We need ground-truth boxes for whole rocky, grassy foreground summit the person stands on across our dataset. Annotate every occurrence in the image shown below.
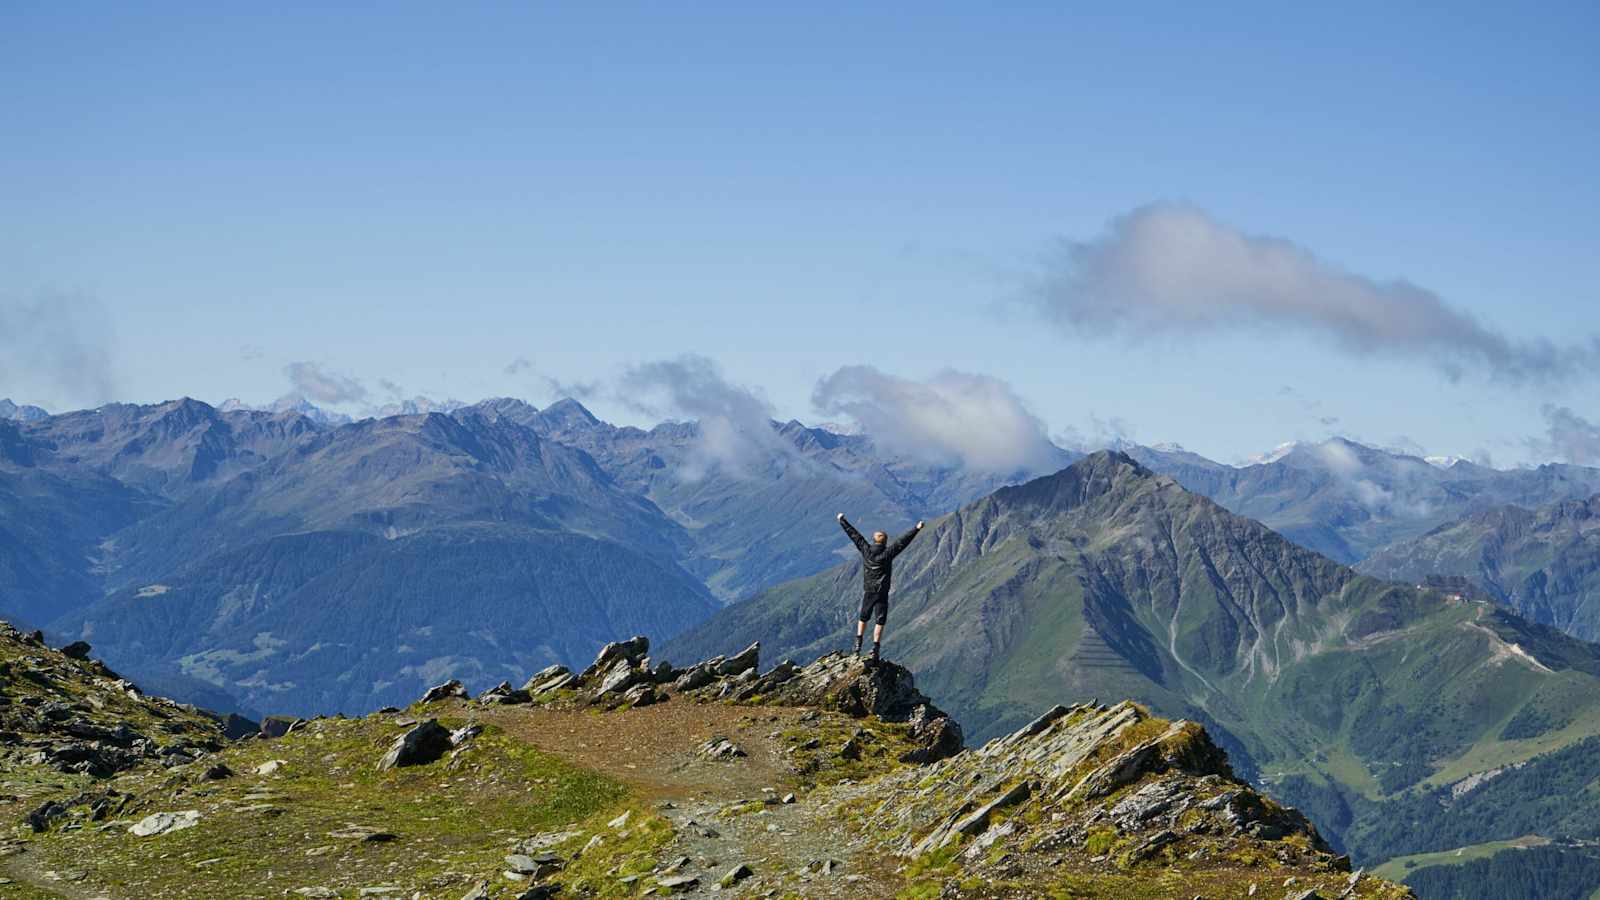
[0,614,1411,900]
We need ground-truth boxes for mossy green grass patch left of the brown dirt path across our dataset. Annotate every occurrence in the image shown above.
[18,716,626,898]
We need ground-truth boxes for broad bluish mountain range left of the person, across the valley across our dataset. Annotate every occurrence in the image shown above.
[9,400,1070,713]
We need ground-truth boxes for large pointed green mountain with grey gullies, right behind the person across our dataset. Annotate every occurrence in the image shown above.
[666,452,1600,883]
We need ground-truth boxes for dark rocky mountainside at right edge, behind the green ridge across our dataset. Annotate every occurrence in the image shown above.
[1358,495,1600,641]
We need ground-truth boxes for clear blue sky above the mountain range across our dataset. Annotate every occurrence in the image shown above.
[0,3,1600,464]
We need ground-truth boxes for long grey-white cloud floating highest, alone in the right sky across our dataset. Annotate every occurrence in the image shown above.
[1030,205,1600,383]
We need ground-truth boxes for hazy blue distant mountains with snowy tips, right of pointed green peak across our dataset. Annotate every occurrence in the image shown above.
[1122,437,1600,564]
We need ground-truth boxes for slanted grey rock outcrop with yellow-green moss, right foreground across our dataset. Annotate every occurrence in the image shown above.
[834,701,1408,898]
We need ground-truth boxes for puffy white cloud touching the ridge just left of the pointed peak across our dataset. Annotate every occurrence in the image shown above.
[811,365,1059,472]
